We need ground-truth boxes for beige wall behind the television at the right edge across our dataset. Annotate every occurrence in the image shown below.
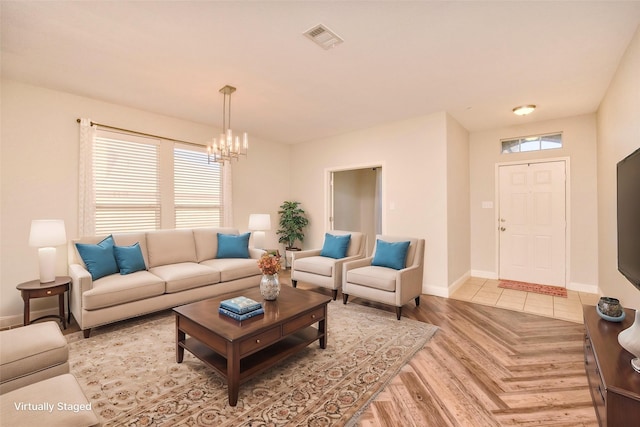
[598,28,640,309]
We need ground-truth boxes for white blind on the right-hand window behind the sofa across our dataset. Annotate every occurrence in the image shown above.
[173,146,224,228]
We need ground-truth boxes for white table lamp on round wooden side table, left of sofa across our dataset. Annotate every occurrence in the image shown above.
[29,219,67,283]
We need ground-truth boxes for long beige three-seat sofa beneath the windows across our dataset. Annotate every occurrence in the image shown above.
[69,227,263,337]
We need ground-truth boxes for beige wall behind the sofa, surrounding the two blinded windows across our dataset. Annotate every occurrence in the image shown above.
[0,80,289,325]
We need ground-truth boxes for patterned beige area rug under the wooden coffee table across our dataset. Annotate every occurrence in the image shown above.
[67,302,437,427]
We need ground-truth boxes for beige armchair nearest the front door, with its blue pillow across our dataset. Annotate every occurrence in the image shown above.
[342,235,424,320]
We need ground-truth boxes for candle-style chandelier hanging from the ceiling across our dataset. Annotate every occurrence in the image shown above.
[207,85,249,163]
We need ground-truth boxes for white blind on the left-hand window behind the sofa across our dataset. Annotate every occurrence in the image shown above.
[93,131,160,234]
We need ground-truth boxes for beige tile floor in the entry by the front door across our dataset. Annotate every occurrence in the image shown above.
[451,277,600,323]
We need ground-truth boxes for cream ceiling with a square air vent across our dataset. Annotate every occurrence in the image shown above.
[0,0,640,143]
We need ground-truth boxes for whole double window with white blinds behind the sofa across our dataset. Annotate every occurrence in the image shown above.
[93,129,223,234]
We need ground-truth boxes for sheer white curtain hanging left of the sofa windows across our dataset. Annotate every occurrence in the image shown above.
[78,119,97,236]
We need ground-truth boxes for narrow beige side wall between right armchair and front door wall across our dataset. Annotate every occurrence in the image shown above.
[447,116,471,285]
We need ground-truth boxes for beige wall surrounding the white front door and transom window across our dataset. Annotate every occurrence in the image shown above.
[470,113,598,292]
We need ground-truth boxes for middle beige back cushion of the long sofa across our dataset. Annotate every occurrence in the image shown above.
[147,229,196,268]
